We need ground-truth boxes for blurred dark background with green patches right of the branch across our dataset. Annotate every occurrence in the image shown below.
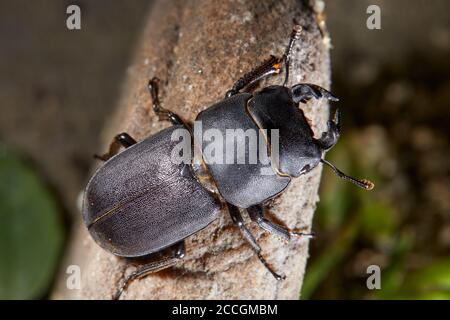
[302,1,450,299]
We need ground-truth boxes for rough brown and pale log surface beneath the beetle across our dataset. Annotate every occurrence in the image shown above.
[53,0,330,299]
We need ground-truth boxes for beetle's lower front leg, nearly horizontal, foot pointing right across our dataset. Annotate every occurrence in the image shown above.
[247,204,315,241]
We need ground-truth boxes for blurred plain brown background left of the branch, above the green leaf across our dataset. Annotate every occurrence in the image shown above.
[0,0,150,298]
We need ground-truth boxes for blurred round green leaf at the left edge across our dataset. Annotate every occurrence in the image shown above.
[0,144,63,299]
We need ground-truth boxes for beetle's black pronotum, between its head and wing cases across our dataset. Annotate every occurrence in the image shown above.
[196,93,290,208]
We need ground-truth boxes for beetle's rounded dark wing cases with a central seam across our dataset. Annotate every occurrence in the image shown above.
[83,125,221,257]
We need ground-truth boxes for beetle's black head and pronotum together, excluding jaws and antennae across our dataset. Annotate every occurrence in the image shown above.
[196,86,322,208]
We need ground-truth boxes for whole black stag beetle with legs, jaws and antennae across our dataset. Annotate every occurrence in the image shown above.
[82,26,373,298]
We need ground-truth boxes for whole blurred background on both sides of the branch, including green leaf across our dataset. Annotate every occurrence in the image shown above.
[0,0,450,299]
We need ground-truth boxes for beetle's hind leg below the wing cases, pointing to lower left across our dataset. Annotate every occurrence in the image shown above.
[114,241,186,300]
